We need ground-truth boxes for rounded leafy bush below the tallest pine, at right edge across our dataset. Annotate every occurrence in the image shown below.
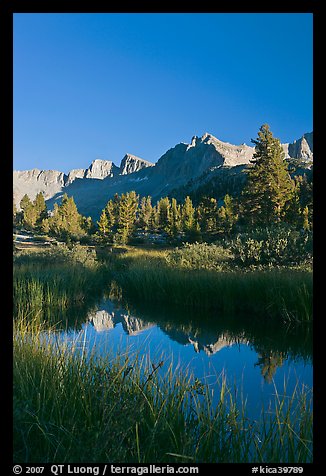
[230,226,312,266]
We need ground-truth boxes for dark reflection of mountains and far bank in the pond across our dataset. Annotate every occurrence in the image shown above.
[86,300,312,365]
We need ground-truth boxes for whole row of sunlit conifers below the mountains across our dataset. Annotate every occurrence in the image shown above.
[14,124,313,244]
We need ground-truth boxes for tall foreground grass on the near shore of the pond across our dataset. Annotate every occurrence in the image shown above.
[13,319,312,463]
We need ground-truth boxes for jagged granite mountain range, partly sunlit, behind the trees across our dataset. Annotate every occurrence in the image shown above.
[13,132,313,219]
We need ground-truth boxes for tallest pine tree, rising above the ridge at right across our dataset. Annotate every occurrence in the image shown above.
[242,124,293,225]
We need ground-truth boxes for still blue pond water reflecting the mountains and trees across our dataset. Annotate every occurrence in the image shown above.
[51,299,313,418]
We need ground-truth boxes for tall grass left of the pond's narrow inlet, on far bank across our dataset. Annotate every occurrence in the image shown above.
[13,247,111,324]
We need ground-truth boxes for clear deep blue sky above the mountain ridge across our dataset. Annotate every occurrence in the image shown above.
[13,13,313,172]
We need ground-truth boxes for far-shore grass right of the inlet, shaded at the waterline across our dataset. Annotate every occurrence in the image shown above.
[109,250,312,322]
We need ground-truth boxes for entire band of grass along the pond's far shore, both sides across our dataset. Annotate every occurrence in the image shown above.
[14,247,312,323]
